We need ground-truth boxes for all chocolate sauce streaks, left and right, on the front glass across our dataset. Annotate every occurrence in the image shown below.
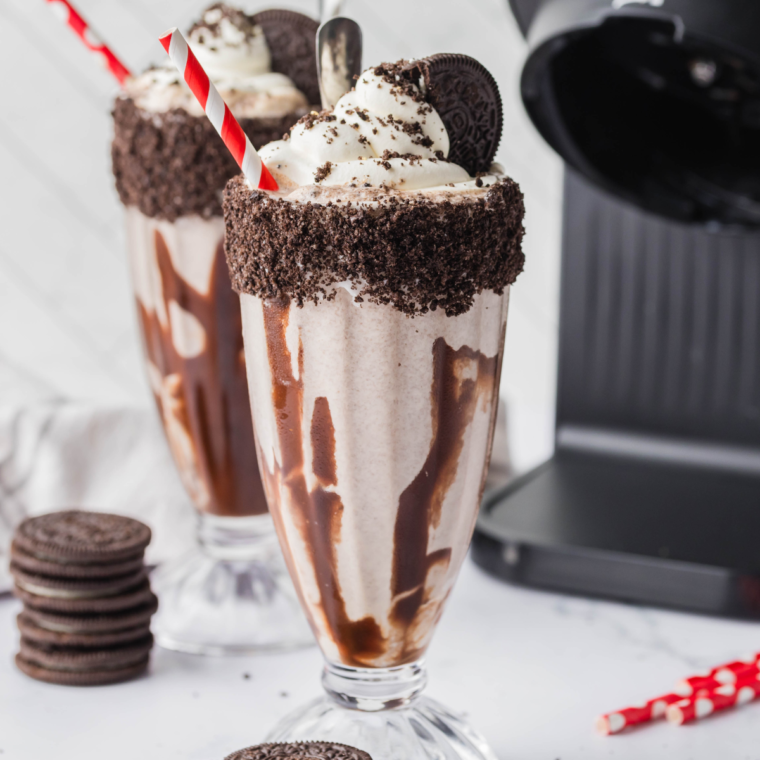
[262,300,500,667]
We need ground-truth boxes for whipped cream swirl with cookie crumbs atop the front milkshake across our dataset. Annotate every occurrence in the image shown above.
[260,69,500,194]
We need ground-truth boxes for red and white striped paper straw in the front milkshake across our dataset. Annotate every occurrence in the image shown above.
[159,28,279,190]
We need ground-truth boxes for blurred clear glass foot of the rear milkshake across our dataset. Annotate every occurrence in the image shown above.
[151,515,314,655]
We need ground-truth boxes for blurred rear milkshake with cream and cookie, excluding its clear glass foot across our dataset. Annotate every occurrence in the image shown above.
[113,4,317,516]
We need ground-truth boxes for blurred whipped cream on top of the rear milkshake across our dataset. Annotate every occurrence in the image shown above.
[127,4,308,118]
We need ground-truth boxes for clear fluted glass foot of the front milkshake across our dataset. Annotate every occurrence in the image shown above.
[266,663,496,760]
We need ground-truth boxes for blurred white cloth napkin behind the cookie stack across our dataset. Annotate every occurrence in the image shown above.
[0,402,195,591]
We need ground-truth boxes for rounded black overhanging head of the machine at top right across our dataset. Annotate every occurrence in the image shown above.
[513,0,760,228]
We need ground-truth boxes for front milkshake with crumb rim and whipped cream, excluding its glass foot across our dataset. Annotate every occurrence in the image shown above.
[225,56,523,667]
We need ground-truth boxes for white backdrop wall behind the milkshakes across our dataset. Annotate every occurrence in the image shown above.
[0,0,561,504]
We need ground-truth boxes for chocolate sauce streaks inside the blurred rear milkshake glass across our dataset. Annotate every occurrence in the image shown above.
[137,230,267,517]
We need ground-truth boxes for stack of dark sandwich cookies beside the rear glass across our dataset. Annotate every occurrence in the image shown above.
[11,510,158,686]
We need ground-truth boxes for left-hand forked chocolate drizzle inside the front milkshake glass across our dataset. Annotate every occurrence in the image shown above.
[263,301,385,667]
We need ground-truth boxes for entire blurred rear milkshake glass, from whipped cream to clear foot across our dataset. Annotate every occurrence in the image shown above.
[113,4,318,654]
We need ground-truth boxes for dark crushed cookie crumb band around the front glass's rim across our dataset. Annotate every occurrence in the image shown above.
[224,177,524,316]
